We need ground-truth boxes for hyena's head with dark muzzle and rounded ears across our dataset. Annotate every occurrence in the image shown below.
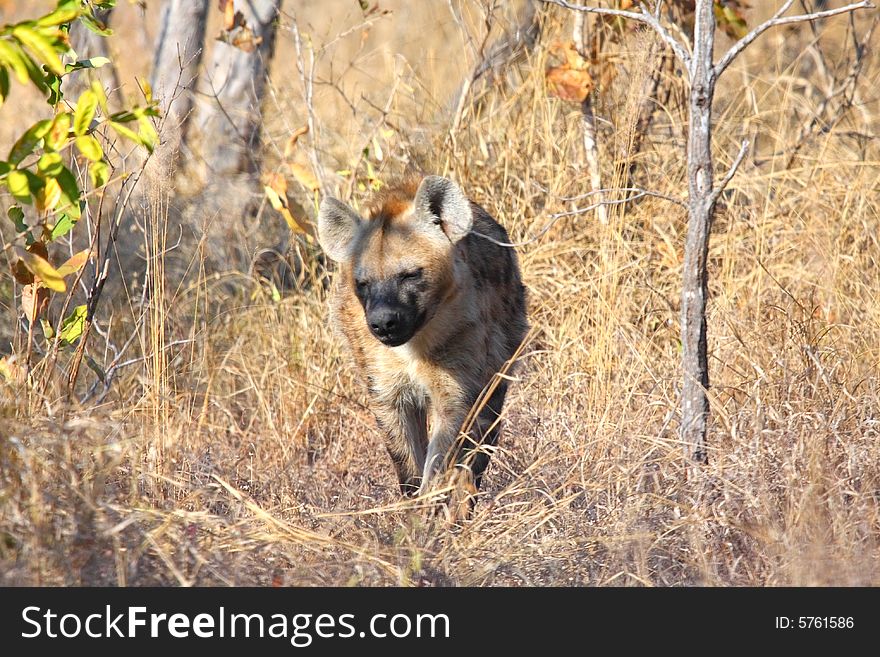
[318,176,473,347]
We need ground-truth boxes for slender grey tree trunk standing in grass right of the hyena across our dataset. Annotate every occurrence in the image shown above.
[681,0,715,463]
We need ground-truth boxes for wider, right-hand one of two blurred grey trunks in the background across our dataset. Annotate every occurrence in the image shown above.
[197,0,281,178]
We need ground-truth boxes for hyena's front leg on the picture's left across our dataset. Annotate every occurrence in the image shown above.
[374,394,428,495]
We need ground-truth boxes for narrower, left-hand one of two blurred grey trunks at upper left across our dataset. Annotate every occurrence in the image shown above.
[150,0,210,160]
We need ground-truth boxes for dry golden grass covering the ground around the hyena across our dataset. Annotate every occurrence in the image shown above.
[0,3,880,586]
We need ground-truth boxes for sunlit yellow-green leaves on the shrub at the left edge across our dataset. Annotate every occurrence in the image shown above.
[0,0,159,358]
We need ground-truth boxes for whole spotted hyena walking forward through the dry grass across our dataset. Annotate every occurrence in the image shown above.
[318,176,528,495]
